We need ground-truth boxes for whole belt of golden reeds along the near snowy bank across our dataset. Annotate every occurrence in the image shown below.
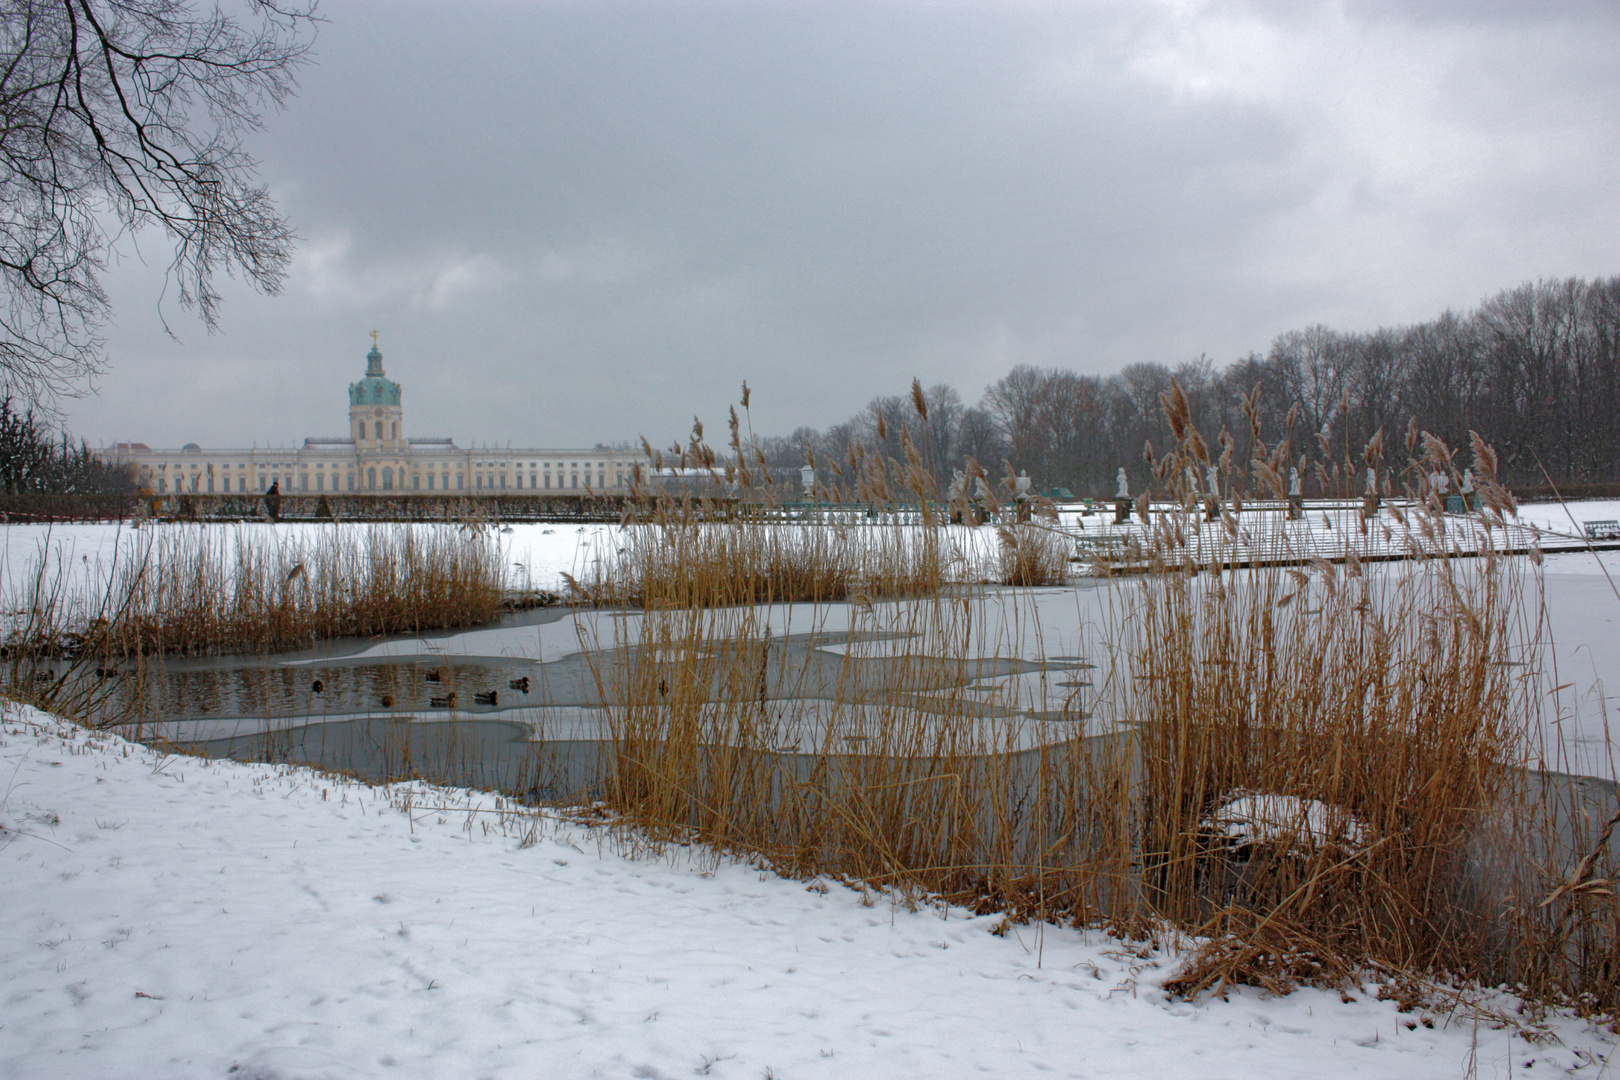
[573,386,1620,1015]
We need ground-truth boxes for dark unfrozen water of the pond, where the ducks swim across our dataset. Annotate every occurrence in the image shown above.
[85,610,1090,798]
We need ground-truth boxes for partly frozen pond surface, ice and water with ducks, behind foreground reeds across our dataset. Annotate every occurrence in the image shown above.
[91,583,1103,790]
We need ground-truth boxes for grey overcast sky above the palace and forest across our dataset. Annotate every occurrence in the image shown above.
[66,0,1620,447]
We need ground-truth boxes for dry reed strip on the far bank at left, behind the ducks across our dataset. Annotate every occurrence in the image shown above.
[0,526,504,664]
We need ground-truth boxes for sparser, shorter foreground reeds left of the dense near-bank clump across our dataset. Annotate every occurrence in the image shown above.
[583,597,1088,894]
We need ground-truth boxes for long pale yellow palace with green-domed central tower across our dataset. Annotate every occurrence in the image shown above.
[102,332,642,499]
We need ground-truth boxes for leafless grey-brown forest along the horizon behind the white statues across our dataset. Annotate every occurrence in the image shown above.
[757,277,1620,495]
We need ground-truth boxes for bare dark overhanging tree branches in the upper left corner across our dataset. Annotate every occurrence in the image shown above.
[0,0,314,403]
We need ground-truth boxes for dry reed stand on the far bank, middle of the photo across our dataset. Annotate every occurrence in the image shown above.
[596,385,1072,609]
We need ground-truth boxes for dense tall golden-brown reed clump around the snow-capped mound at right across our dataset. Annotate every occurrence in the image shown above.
[1128,527,1534,991]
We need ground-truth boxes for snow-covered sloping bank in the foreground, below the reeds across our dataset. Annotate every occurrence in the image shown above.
[0,706,1615,1080]
